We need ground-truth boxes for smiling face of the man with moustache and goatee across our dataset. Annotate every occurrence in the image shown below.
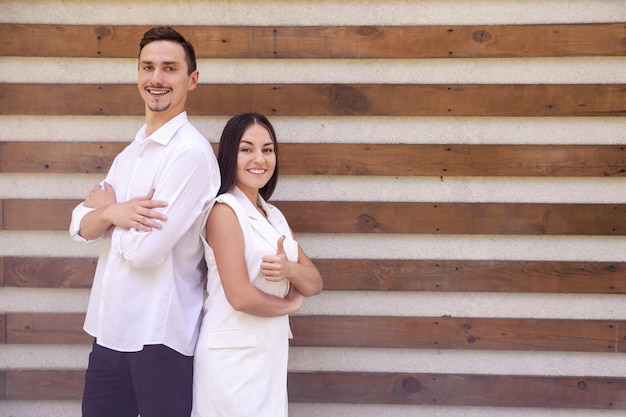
[137,41,198,118]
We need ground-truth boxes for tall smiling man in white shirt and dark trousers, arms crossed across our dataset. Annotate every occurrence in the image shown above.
[70,27,220,417]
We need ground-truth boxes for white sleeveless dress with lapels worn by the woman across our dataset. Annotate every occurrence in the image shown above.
[192,187,298,417]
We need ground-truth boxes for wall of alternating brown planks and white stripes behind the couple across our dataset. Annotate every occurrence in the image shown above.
[0,0,626,417]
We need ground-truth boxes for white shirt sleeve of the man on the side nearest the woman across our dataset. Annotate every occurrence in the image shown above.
[111,142,220,268]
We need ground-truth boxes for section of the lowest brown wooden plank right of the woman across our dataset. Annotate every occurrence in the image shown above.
[288,372,626,410]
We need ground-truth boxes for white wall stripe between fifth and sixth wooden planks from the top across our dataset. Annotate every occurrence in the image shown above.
[0,287,626,320]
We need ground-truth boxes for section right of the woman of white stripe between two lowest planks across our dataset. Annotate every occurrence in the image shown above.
[289,347,626,378]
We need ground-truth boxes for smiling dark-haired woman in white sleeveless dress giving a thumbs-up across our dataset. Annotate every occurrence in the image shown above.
[192,113,322,417]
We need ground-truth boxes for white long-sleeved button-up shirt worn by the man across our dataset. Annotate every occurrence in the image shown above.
[70,112,220,356]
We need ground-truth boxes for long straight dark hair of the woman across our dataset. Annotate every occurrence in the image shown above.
[217,113,278,201]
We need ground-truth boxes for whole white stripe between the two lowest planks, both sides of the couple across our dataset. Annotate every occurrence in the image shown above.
[0,344,624,378]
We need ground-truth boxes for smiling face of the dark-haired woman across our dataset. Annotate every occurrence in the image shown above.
[235,124,276,194]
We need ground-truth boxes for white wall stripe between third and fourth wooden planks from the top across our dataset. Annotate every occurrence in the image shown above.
[0,174,626,204]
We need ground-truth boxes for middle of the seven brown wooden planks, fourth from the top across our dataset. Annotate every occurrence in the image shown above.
[3,199,626,236]
